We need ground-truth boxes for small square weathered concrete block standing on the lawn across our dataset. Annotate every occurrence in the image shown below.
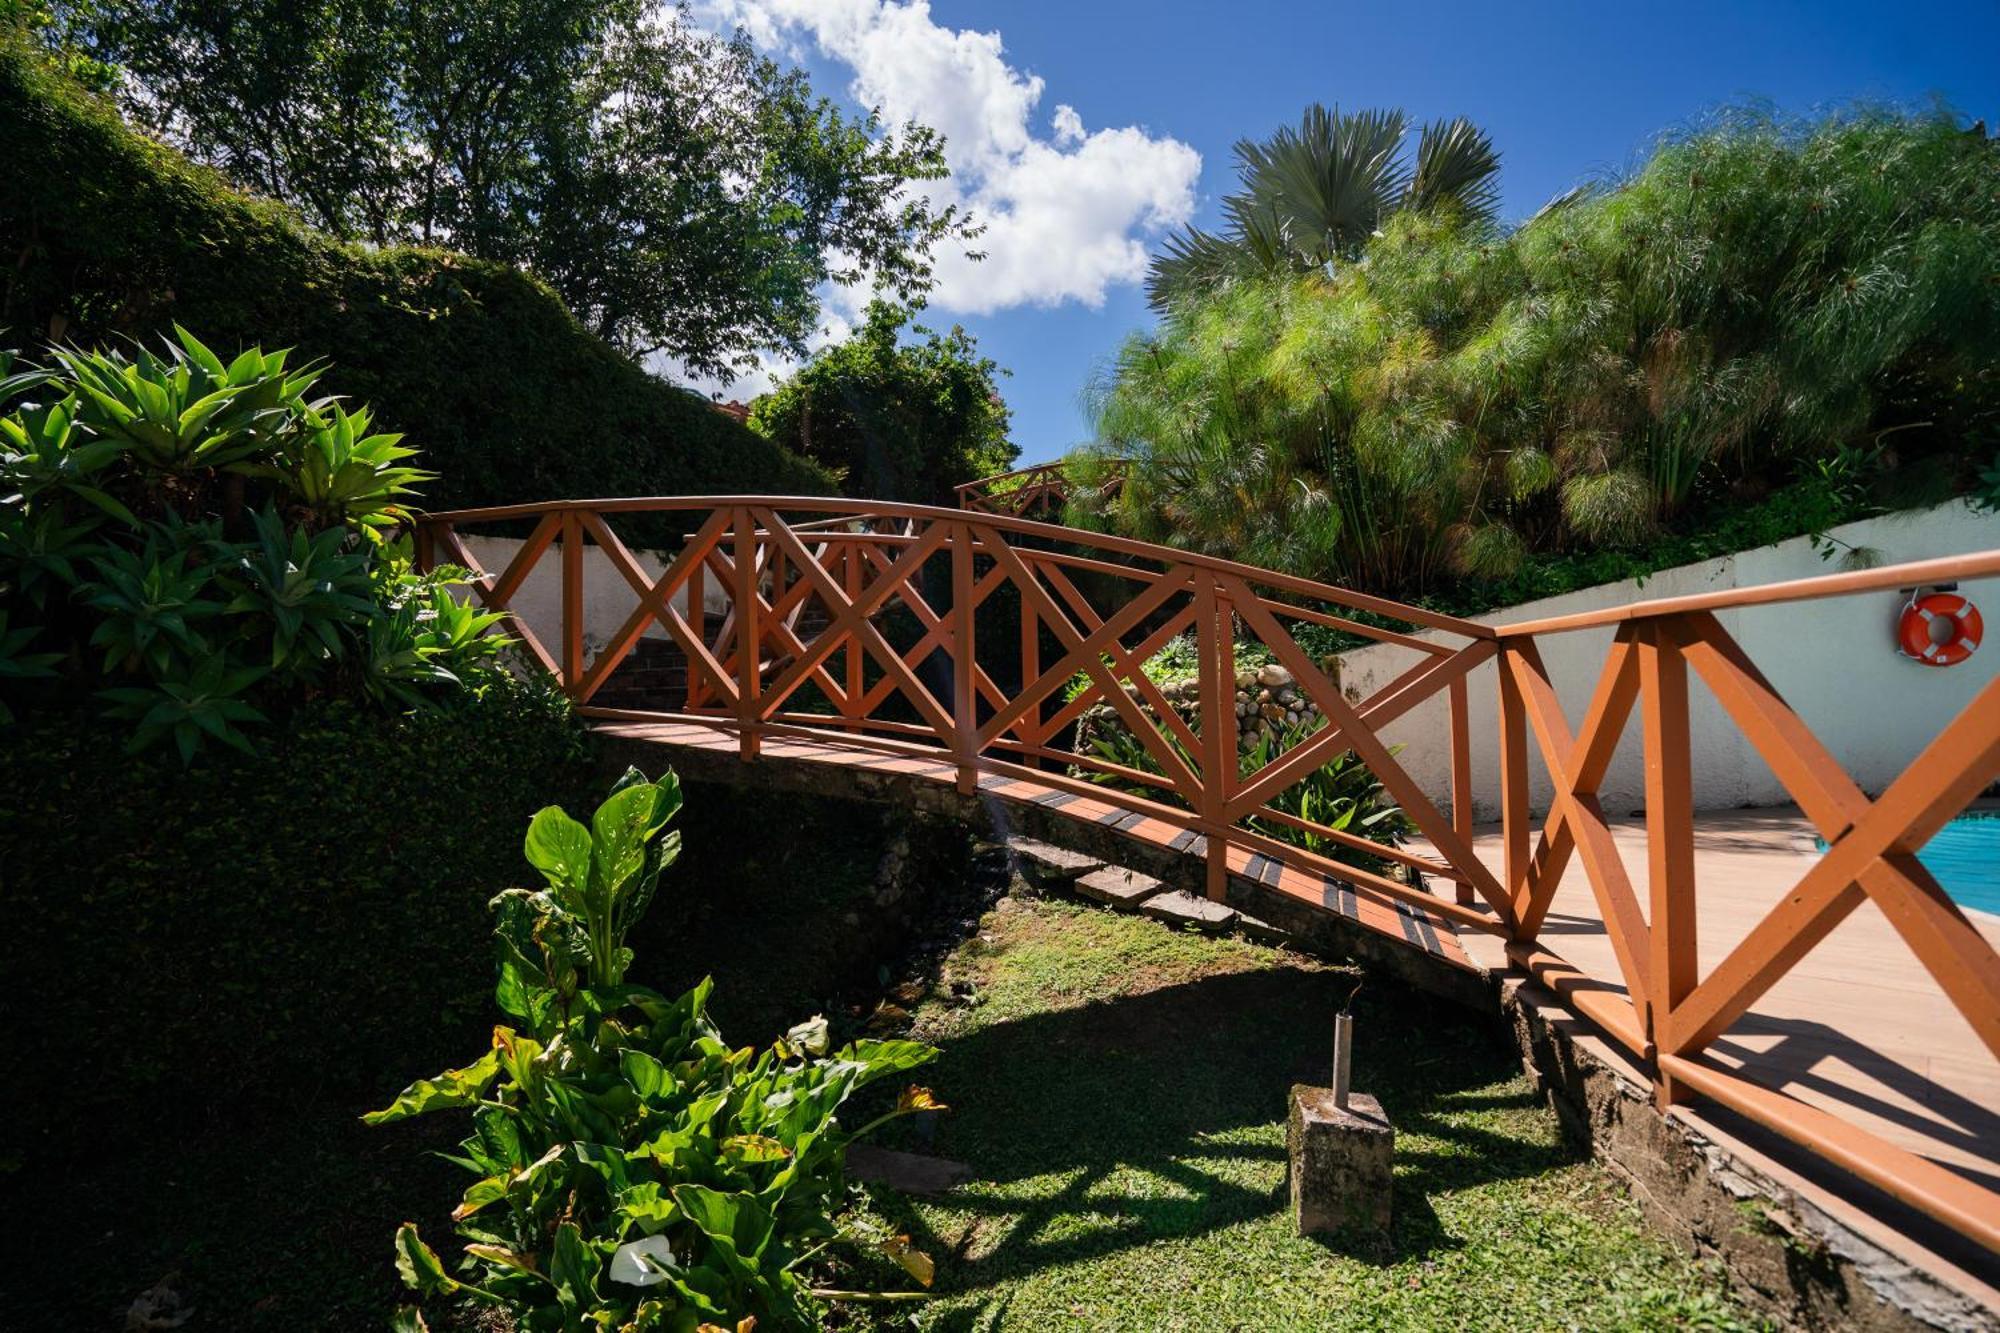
[1286,1083,1396,1237]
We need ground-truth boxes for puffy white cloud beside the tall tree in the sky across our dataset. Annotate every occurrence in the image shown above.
[696,0,1202,314]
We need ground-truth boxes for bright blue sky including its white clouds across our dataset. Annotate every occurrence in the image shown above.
[702,0,2000,462]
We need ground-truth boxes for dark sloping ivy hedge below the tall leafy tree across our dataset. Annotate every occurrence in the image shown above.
[0,38,832,508]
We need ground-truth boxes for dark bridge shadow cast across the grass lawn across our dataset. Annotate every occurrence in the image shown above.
[882,967,1576,1288]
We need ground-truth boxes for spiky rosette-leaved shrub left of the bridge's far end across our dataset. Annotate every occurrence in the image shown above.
[0,330,532,761]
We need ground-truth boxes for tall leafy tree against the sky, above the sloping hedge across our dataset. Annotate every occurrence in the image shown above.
[54,0,970,372]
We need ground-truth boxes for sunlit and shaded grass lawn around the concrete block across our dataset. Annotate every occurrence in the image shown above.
[852,899,1754,1329]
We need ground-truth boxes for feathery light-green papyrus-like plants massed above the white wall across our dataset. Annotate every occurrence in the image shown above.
[1082,112,2000,594]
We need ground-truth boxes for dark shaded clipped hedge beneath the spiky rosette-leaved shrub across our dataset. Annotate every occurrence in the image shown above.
[0,685,600,1153]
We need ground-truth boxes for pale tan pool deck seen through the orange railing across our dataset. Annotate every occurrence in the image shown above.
[1460,807,2000,1189]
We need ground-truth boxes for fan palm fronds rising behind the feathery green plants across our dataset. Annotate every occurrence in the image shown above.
[1146,102,1500,310]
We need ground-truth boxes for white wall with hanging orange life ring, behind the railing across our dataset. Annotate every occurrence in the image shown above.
[1342,500,2000,819]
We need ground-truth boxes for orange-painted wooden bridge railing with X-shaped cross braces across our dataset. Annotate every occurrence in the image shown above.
[418,496,2000,1253]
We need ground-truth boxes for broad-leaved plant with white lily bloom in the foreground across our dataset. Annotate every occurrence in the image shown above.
[382,769,936,1333]
